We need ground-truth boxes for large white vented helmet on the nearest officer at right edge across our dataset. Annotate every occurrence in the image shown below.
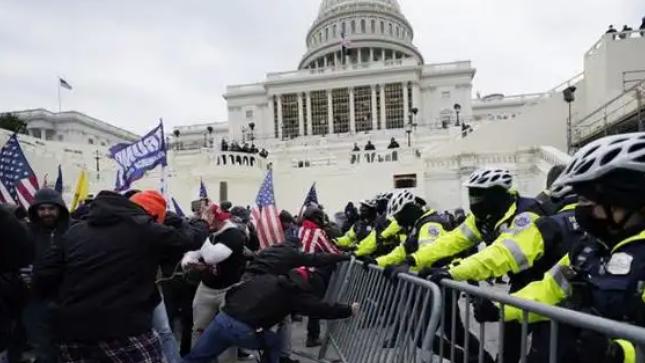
[553,132,645,185]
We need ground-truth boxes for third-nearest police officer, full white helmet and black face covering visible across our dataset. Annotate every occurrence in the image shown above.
[399,168,542,362]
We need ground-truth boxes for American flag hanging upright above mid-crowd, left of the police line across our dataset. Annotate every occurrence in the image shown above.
[251,170,284,248]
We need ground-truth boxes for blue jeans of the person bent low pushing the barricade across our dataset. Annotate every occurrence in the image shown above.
[184,312,281,363]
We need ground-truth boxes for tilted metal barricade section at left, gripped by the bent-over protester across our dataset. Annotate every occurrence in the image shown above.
[318,260,441,363]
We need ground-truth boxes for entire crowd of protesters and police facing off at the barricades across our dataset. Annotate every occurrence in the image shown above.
[0,133,645,363]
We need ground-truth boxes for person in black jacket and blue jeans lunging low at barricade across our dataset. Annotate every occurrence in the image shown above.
[184,268,359,363]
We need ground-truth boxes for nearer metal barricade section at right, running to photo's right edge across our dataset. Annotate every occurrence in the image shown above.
[432,280,645,363]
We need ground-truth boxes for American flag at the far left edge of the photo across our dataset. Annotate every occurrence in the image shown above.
[0,134,39,208]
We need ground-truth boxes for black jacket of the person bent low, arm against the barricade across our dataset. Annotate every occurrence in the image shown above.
[222,275,352,329]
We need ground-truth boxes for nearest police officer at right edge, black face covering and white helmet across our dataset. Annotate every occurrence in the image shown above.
[505,133,645,363]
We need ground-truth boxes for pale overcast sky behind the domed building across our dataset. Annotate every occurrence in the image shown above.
[0,0,645,133]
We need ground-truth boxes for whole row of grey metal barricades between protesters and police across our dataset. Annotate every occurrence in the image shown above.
[318,261,645,363]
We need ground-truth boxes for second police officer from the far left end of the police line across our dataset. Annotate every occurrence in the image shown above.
[354,192,405,259]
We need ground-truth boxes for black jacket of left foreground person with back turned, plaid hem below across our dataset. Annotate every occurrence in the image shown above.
[34,192,204,342]
